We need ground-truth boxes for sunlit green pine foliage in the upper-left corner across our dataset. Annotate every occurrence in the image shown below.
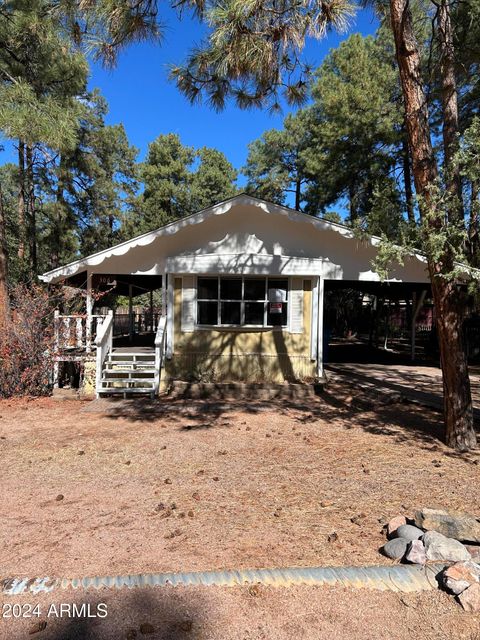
[0,0,88,148]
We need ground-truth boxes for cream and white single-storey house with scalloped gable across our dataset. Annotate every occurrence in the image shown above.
[41,194,429,395]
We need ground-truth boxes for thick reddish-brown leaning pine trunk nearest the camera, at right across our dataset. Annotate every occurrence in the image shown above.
[390,0,476,450]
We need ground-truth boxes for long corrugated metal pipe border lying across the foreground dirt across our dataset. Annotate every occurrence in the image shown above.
[0,563,448,596]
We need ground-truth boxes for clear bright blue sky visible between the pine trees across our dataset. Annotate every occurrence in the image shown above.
[0,10,377,180]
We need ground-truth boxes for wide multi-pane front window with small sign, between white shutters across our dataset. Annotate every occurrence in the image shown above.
[197,277,288,327]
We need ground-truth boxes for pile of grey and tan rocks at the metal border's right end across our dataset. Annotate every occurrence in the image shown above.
[381,509,480,611]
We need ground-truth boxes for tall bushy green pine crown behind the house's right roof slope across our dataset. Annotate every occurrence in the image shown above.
[303,32,404,229]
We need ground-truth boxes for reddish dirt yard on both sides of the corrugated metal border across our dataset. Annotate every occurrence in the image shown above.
[0,381,480,640]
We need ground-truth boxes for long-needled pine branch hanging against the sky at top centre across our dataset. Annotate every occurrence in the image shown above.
[171,0,354,110]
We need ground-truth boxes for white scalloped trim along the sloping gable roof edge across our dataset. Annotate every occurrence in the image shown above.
[39,193,424,283]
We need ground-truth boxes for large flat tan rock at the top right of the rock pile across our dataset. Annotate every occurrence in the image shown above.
[415,509,480,542]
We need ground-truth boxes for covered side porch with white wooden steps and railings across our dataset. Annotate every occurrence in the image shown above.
[54,274,166,398]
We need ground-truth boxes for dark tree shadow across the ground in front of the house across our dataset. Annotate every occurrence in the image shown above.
[81,380,478,461]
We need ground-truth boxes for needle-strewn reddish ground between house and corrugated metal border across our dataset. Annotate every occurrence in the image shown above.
[0,383,480,577]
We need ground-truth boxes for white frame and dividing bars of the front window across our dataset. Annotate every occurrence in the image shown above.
[195,274,291,331]
